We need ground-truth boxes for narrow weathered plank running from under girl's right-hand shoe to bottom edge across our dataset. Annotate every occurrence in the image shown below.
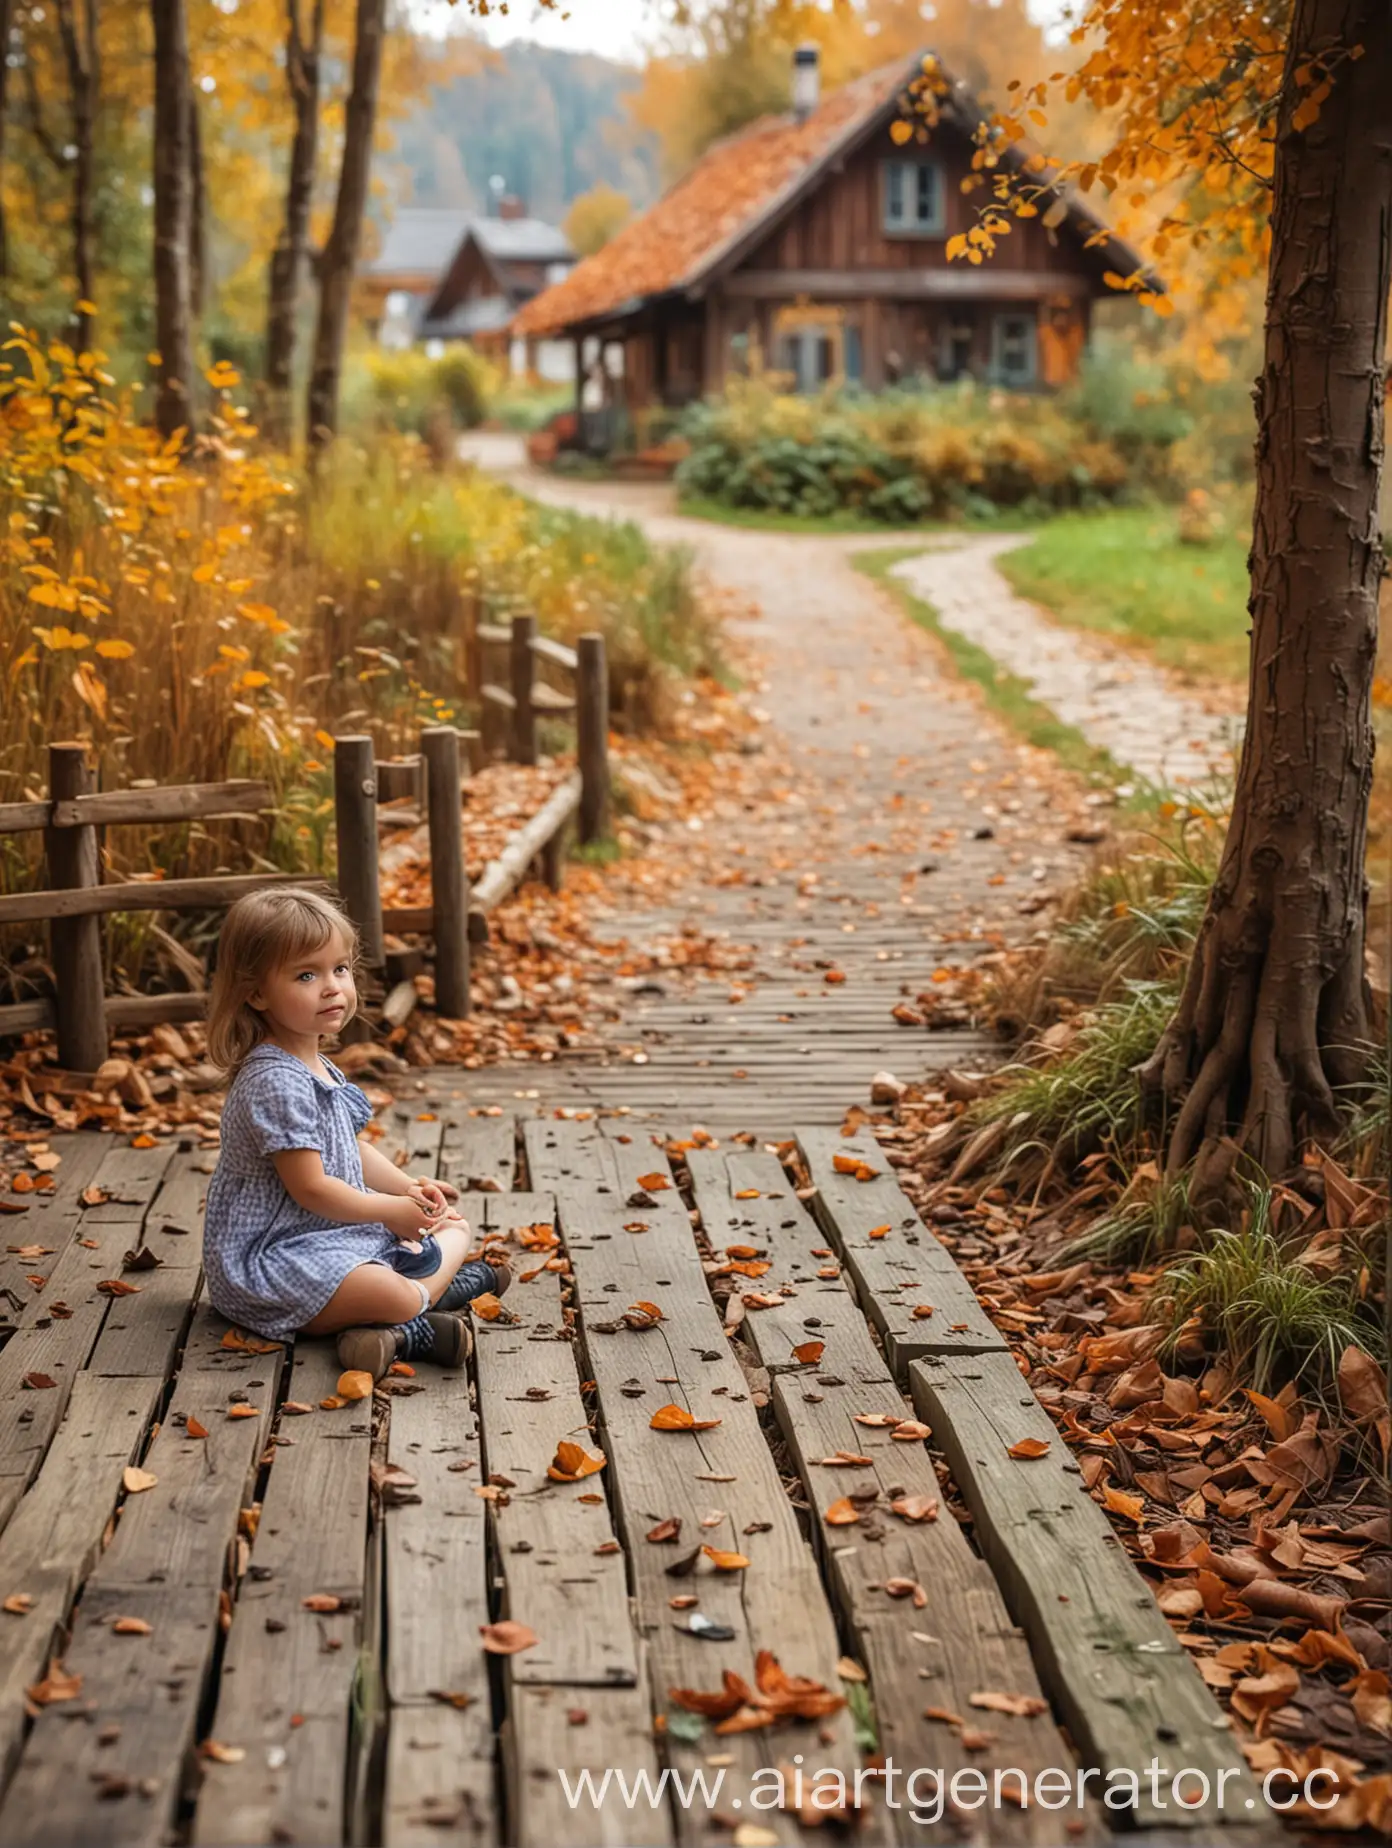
[383,1368,503,1848]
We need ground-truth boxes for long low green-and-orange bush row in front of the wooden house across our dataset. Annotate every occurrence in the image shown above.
[677,377,1153,525]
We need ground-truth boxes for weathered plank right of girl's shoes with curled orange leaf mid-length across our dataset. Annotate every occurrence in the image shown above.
[464,1194,638,1687]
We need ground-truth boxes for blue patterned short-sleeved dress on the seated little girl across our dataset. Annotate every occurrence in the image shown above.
[203,1040,440,1342]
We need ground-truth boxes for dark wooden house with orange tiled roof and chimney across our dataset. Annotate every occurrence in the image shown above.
[514,46,1159,432]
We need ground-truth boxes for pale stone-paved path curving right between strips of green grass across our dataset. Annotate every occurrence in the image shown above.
[895,534,1237,789]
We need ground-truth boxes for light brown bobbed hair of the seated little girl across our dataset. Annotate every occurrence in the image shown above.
[207,885,359,1077]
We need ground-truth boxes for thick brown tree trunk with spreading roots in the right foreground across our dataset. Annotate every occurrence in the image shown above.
[1141,0,1392,1188]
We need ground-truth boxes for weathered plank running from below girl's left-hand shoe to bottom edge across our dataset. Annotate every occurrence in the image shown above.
[192,1342,375,1842]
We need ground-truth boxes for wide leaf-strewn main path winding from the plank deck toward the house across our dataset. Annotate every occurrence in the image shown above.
[428,438,1098,1129]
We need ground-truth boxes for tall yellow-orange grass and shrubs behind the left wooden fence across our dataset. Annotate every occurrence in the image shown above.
[0,340,715,889]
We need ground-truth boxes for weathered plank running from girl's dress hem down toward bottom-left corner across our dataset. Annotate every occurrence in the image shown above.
[0,1310,283,1848]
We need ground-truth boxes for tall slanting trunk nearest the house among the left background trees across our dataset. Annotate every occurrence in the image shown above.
[307,0,386,449]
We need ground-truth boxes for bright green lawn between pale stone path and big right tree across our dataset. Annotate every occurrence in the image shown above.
[996,506,1248,680]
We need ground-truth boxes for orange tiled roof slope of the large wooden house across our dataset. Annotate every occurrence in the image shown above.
[514,59,917,334]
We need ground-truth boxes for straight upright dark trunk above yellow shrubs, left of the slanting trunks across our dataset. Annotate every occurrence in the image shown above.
[150,0,194,438]
